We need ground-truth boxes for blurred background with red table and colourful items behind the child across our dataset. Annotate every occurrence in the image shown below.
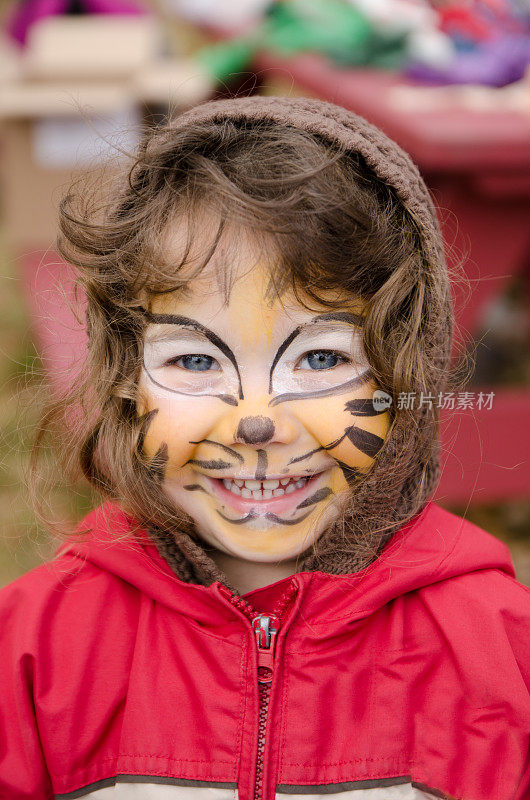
[0,0,530,586]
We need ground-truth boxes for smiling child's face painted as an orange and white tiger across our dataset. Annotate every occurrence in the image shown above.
[138,225,390,563]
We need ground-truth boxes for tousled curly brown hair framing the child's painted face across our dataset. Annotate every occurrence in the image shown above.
[29,108,453,580]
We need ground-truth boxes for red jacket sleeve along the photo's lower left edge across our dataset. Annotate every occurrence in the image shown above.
[0,576,54,800]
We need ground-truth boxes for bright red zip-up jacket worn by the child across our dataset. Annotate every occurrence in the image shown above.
[0,503,530,800]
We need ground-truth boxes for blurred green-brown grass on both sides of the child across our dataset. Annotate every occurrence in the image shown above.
[0,234,530,586]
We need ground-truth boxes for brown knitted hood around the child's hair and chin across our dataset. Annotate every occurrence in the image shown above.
[139,97,452,585]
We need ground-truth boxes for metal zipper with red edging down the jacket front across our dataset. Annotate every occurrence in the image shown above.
[220,585,298,800]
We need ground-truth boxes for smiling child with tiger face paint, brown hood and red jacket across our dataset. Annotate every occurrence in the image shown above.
[0,97,530,800]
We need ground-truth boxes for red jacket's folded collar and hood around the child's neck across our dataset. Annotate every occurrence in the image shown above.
[58,502,514,625]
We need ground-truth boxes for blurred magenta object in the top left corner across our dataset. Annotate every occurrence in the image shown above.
[7,0,147,45]
